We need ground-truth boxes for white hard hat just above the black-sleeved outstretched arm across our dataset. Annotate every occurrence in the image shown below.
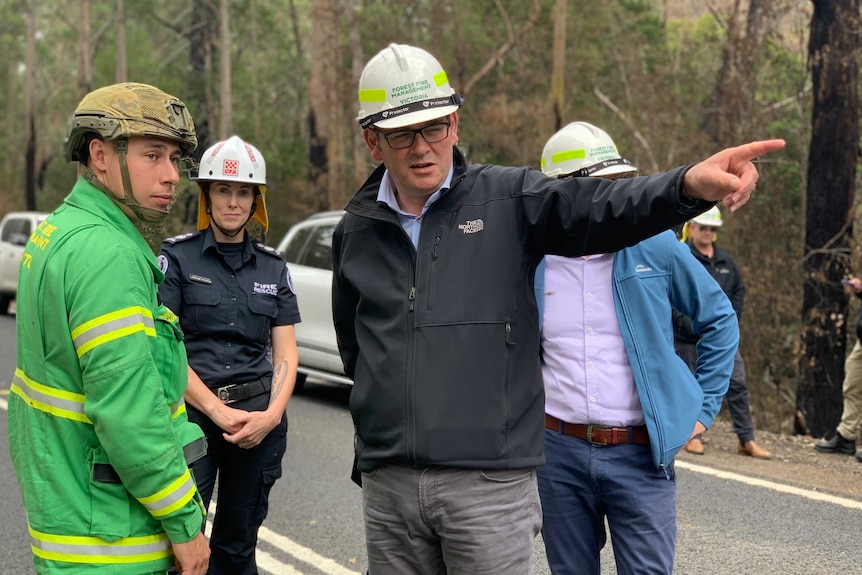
[542,122,638,178]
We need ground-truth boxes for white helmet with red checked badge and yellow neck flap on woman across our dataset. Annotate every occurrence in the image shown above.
[196,136,269,232]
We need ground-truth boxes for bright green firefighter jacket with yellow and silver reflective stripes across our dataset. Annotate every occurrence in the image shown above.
[8,179,205,574]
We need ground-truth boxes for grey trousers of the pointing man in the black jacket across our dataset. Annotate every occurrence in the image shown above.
[362,465,542,575]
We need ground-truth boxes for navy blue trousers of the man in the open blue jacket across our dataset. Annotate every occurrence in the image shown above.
[536,429,676,575]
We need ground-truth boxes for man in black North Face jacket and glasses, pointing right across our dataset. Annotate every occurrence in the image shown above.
[332,44,783,575]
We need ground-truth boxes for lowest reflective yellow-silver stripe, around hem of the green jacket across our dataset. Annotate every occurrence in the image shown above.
[28,525,173,564]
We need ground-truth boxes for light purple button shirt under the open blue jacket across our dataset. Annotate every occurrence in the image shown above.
[542,254,644,426]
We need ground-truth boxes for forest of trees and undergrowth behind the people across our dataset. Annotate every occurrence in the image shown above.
[0,0,862,436]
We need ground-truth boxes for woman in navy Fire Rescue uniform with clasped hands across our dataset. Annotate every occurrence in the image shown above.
[159,136,300,575]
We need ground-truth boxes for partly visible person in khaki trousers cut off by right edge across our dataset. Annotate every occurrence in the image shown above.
[814,277,862,462]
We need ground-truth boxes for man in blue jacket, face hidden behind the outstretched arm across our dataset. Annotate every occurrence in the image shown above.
[535,122,739,575]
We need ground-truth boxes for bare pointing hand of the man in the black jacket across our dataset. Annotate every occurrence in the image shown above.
[683,140,784,212]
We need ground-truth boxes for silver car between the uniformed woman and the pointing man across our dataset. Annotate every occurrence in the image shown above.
[278,210,353,391]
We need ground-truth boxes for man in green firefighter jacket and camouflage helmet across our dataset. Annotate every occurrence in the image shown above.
[8,82,210,575]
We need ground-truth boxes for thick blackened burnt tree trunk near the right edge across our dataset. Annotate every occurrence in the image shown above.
[795,0,860,437]
